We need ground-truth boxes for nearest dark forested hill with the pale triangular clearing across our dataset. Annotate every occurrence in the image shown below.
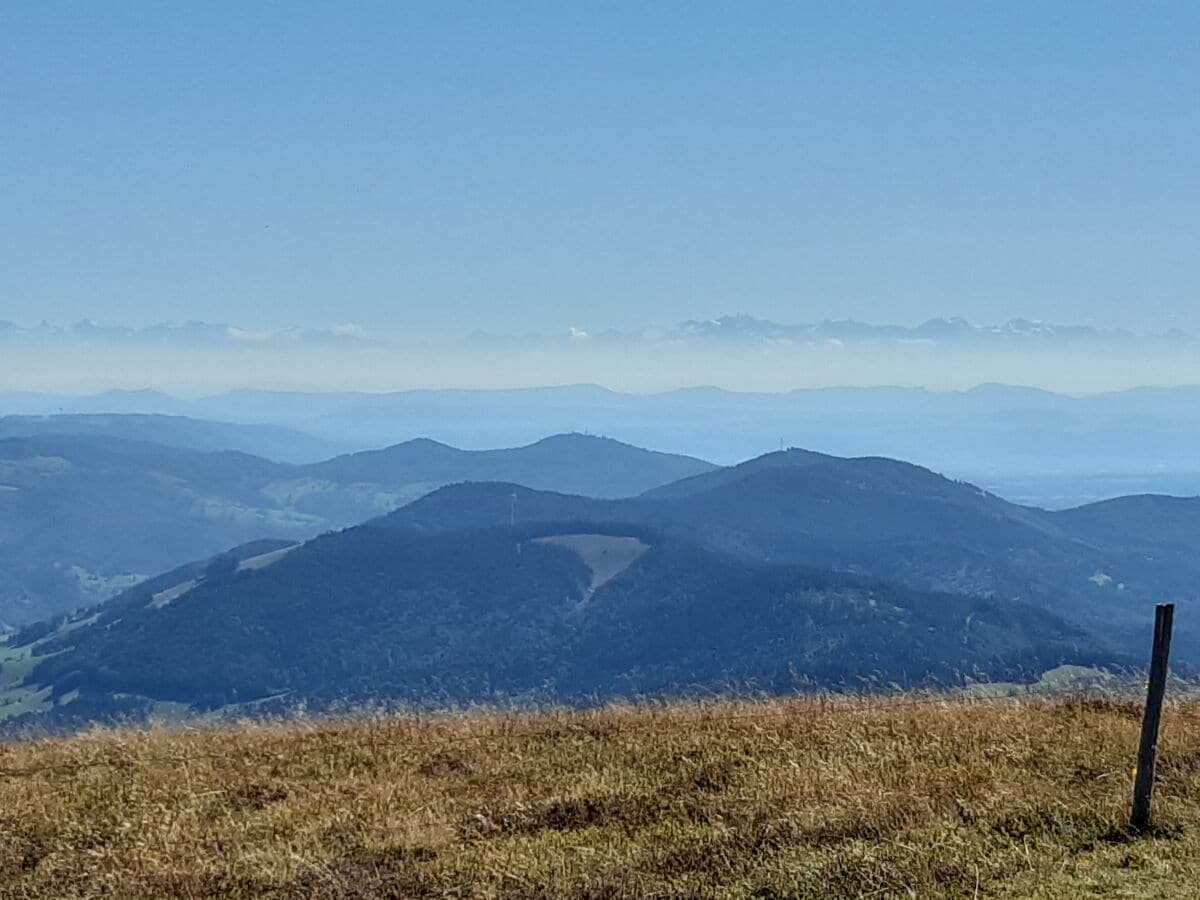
[0,523,1114,734]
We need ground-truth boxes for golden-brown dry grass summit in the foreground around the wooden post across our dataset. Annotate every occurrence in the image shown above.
[0,700,1200,898]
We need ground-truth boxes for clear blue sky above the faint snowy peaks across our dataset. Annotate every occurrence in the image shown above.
[0,0,1200,335]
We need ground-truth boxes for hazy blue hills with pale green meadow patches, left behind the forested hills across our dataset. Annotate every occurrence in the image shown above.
[0,432,713,625]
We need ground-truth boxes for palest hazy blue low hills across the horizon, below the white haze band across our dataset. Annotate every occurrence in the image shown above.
[7,385,1200,508]
